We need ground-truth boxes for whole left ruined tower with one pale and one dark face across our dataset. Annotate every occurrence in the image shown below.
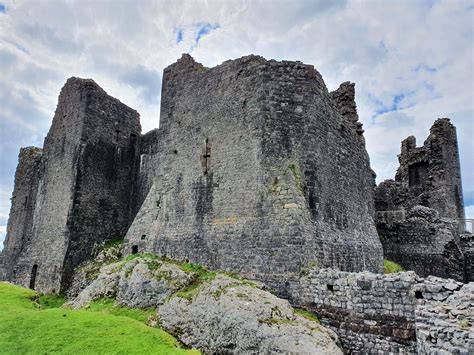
[3,78,141,292]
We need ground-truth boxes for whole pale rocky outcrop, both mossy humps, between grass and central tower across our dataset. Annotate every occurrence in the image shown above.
[66,255,342,354]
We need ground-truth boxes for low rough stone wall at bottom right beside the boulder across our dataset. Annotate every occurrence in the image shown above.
[290,269,474,354]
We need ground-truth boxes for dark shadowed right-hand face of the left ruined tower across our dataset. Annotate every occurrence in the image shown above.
[62,80,141,288]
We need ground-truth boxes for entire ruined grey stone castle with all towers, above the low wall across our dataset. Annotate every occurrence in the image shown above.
[0,55,472,299]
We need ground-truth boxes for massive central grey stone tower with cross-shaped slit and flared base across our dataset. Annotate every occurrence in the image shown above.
[126,55,382,294]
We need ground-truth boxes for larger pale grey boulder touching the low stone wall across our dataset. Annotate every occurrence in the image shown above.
[158,275,341,354]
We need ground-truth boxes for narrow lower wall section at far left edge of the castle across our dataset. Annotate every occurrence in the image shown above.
[1,147,42,280]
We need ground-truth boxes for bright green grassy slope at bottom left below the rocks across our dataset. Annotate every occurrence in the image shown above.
[0,282,198,354]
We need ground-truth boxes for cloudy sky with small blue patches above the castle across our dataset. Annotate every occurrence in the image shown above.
[0,0,474,249]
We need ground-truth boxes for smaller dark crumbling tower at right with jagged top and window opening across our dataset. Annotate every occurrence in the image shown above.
[375,118,473,281]
